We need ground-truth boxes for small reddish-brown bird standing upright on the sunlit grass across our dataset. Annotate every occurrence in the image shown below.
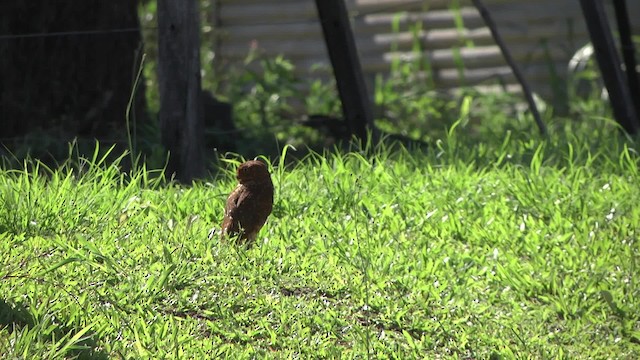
[221,160,273,244]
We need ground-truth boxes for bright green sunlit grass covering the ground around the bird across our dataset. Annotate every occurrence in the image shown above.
[0,119,640,359]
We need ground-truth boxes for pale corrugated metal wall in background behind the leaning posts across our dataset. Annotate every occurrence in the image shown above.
[216,0,640,96]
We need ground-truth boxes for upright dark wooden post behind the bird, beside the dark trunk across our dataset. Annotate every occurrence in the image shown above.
[157,0,205,183]
